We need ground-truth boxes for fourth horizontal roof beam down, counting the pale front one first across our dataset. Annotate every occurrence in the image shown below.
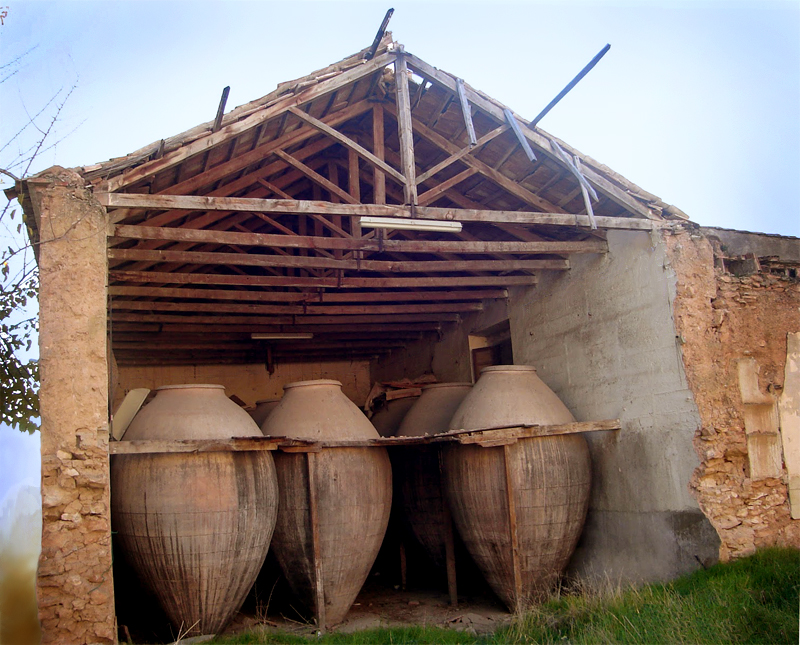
[109,269,538,290]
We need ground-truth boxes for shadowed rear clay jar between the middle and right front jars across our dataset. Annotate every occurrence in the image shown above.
[392,383,472,568]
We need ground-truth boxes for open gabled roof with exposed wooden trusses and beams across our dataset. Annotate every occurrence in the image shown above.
[43,34,685,365]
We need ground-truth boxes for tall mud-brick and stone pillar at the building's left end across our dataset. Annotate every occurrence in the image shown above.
[28,168,116,644]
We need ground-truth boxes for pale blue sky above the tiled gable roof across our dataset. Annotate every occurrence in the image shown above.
[0,0,800,498]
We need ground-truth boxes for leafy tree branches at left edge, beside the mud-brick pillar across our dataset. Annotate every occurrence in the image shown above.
[0,48,75,433]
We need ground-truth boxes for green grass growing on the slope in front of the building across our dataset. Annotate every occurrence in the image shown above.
[214,548,800,645]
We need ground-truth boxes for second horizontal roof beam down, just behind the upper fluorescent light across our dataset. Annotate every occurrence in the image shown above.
[110,224,608,254]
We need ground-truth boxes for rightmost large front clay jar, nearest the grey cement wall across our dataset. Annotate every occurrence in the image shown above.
[443,365,591,611]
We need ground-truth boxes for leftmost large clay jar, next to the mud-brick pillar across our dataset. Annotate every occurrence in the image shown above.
[111,385,278,634]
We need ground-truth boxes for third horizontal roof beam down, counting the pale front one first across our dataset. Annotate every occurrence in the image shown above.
[108,248,569,273]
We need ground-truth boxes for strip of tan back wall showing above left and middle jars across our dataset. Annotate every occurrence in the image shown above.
[112,361,371,410]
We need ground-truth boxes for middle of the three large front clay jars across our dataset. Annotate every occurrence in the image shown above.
[261,380,392,627]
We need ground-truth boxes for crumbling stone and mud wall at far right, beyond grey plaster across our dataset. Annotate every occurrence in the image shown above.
[666,226,800,560]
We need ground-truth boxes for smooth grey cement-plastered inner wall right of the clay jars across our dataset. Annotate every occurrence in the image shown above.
[508,231,719,580]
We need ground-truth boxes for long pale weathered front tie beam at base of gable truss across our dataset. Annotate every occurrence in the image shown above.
[95,193,658,231]
